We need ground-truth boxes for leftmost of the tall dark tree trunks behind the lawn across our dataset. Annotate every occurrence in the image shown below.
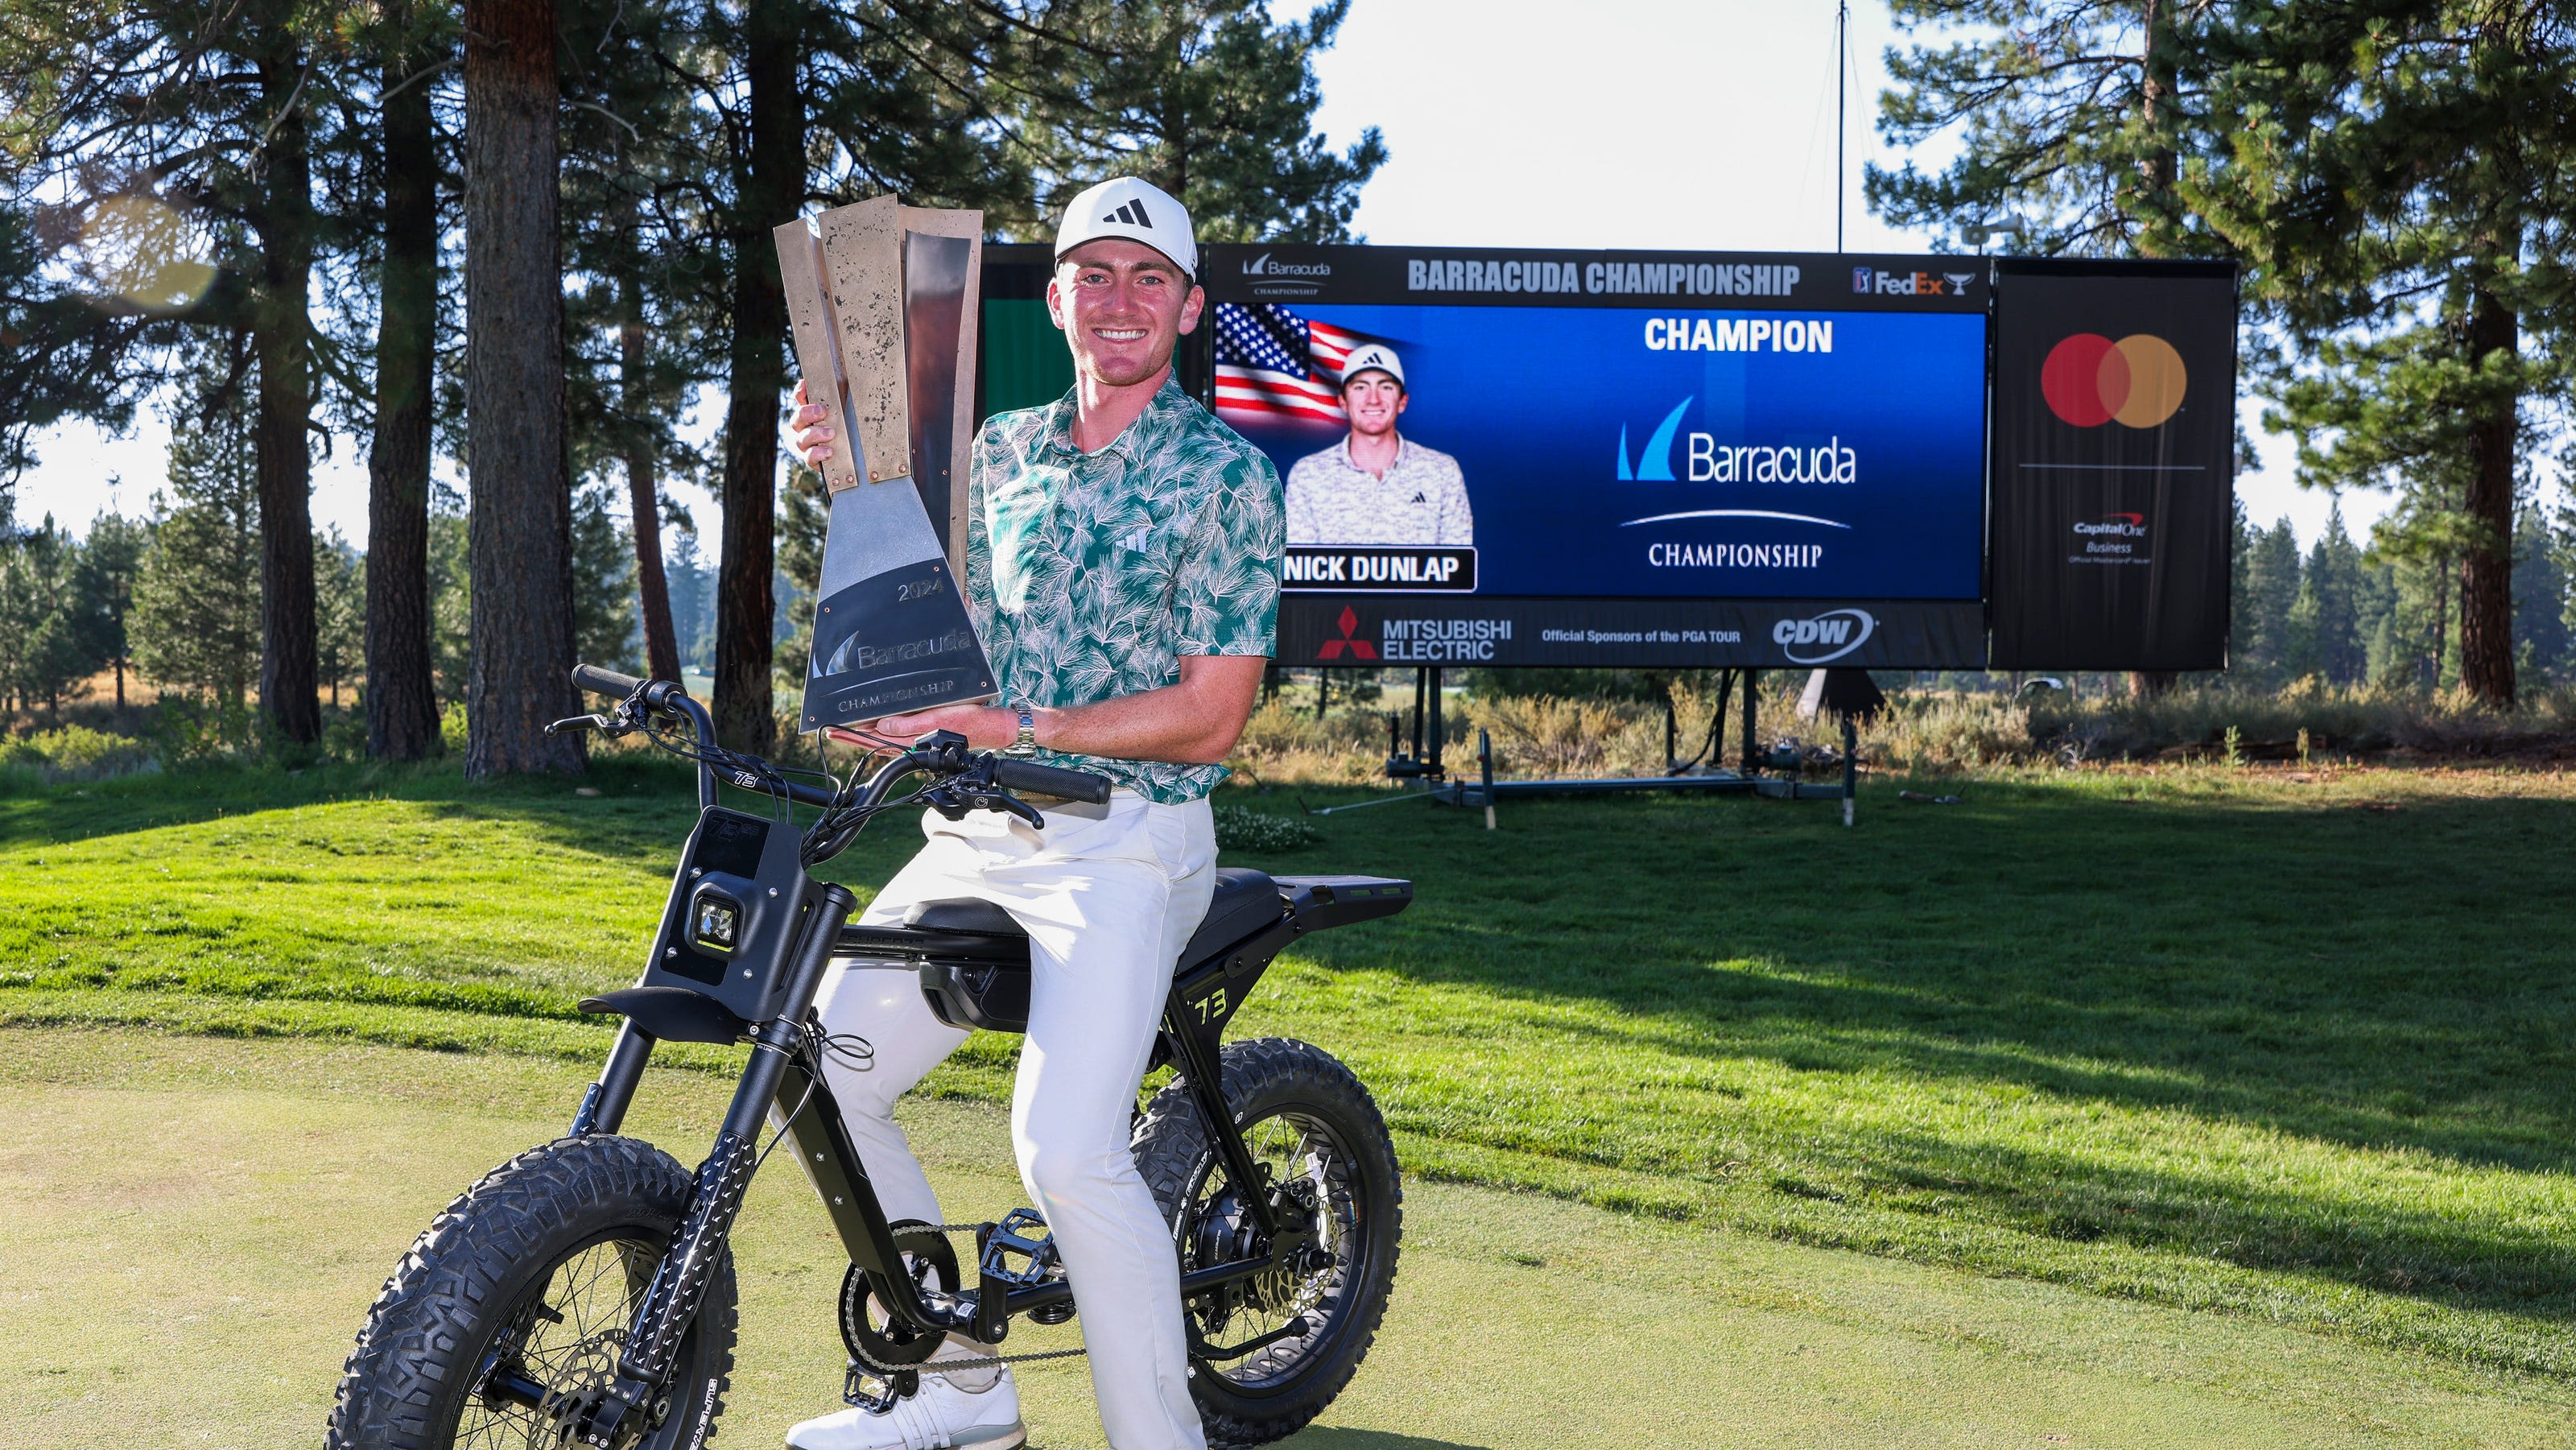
[253,49,322,742]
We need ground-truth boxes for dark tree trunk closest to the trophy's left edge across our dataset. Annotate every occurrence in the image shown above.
[716,0,803,752]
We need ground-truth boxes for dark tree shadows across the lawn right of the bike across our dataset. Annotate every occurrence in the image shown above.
[1298,783,2576,1321]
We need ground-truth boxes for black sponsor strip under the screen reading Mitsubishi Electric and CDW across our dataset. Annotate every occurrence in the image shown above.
[1278,595,1986,670]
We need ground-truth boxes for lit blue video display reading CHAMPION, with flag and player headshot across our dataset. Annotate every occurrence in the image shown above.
[1211,250,1986,615]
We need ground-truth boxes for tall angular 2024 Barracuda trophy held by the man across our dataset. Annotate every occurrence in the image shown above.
[773,196,994,731]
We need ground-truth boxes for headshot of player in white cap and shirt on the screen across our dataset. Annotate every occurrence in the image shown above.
[1288,342,1476,543]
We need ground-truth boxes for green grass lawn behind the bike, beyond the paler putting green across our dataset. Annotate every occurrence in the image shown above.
[0,762,2576,1378]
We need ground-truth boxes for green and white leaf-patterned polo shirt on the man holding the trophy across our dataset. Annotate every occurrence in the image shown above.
[966,381,1288,806]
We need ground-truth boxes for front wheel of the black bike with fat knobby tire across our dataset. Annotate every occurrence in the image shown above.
[324,1136,734,1450]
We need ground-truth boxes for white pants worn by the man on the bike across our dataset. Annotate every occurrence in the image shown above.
[816,791,1216,1450]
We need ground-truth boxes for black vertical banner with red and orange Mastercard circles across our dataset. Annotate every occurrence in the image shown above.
[1986,260,2236,670]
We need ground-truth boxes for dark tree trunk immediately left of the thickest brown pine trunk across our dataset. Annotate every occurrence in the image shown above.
[365,8,438,760]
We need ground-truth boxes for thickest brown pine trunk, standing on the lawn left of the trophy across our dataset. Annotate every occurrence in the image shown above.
[466,0,582,780]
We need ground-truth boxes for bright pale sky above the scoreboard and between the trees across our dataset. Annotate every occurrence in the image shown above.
[18,0,2388,546]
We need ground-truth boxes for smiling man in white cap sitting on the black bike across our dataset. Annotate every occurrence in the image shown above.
[767,178,1283,1450]
